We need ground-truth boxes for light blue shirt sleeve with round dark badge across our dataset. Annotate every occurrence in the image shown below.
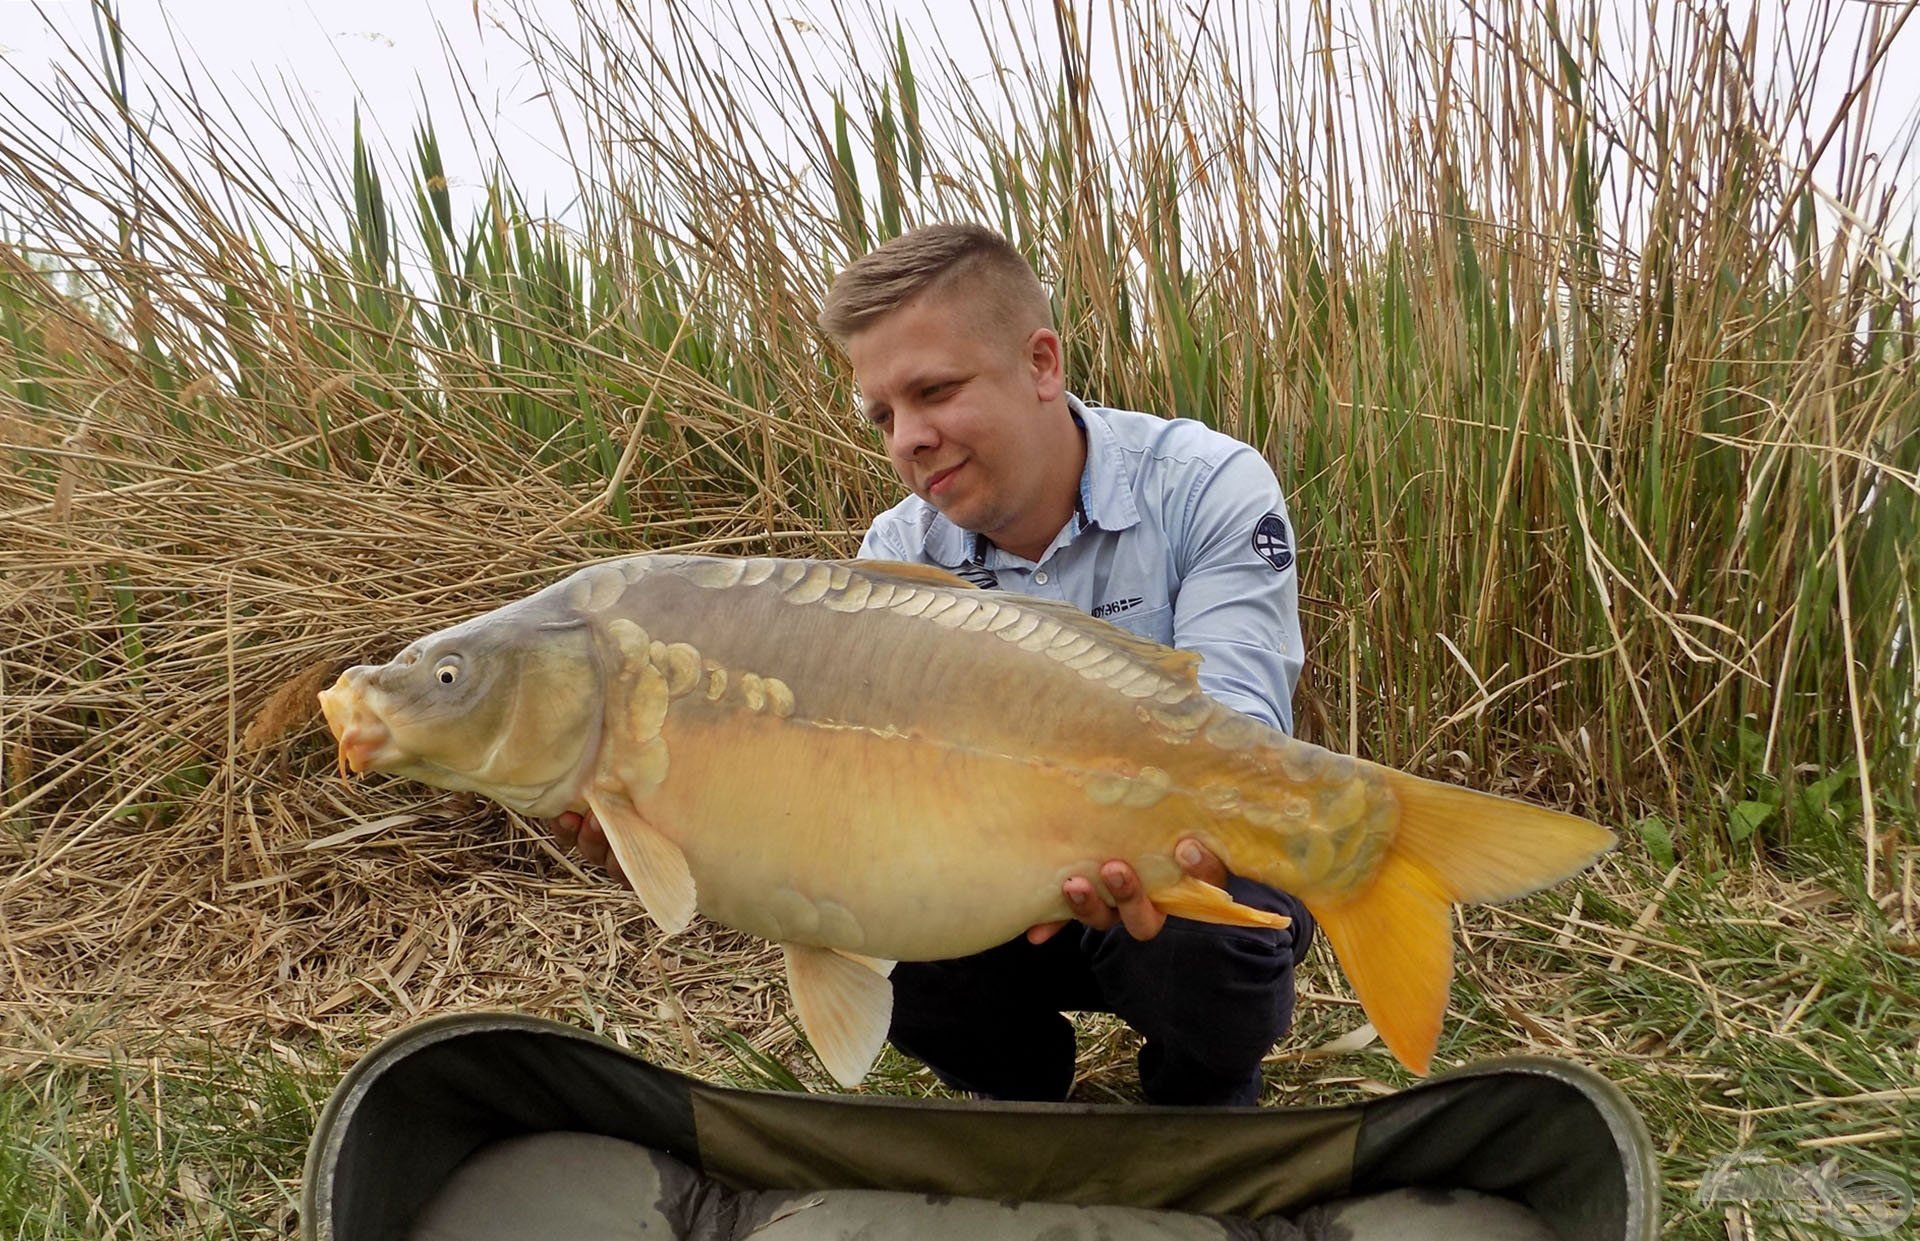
[1173,448,1306,734]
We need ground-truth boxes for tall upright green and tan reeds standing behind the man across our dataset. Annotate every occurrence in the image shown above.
[0,2,1920,888]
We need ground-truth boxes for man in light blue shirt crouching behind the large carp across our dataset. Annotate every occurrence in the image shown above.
[555,225,1313,1105]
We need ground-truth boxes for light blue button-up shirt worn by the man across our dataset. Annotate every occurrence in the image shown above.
[860,394,1306,734]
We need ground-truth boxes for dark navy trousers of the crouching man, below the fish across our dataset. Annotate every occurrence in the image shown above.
[889,876,1313,1107]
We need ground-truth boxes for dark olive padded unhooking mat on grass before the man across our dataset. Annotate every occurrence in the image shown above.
[301,1014,1659,1241]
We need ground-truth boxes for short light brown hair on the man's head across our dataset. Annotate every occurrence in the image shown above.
[820,223,1054,348]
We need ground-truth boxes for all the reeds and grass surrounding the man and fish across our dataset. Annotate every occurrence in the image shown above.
[0,4,1920,1237]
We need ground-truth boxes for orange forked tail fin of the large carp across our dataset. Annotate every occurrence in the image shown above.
[1309,770,1615,1076]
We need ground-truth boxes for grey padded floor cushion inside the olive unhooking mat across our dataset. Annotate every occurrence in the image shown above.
[409,1133,1553,1241]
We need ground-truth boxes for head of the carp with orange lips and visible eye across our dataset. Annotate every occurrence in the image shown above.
[321,605,605,818]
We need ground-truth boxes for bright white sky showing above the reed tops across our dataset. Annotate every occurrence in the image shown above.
[0,0,1920,272]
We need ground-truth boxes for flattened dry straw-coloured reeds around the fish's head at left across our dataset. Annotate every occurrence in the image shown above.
[0,457,840,1068]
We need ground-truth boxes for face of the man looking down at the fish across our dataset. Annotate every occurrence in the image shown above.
[847,292,1062,538]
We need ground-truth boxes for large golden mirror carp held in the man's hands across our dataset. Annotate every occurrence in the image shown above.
[321,555,1615,1085]
